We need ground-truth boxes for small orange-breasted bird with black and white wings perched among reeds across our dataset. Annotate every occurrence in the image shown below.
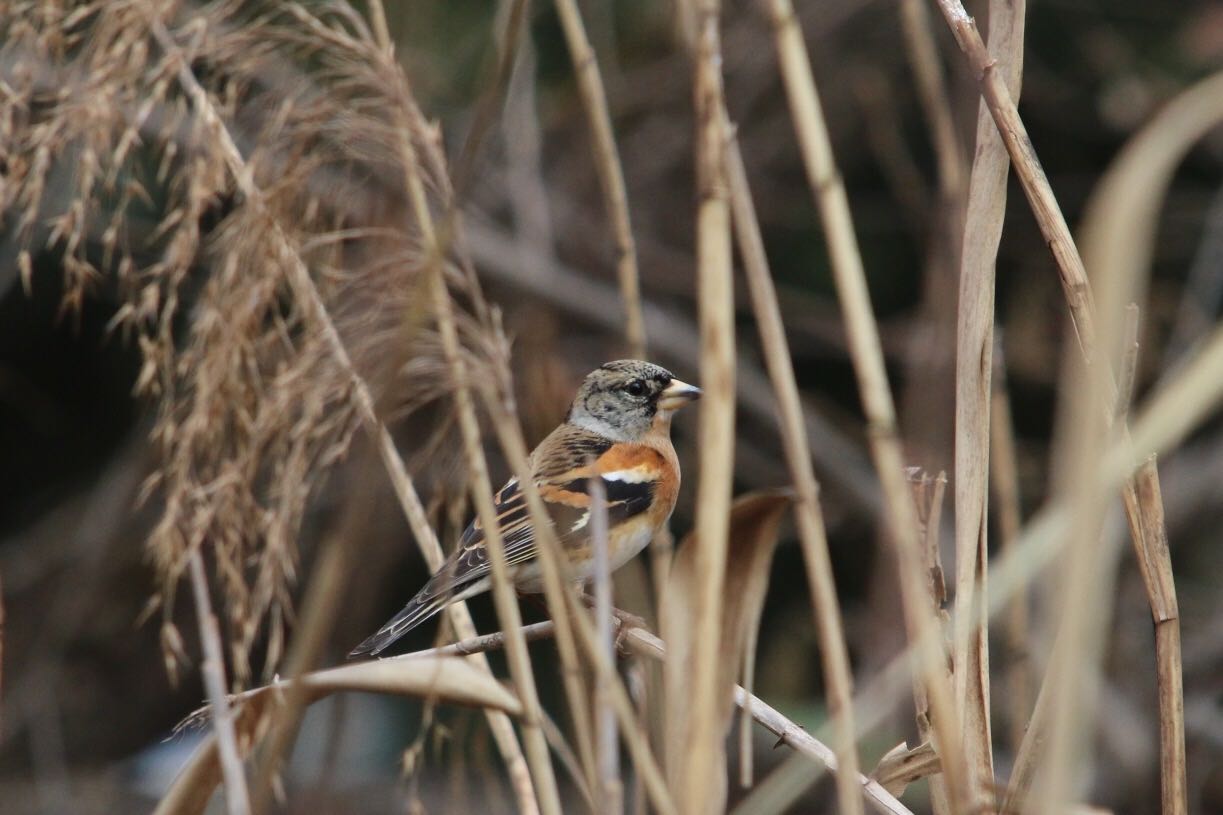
[349,360,701,657]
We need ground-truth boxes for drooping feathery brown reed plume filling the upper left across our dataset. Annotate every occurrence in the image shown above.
[0,1,499,682]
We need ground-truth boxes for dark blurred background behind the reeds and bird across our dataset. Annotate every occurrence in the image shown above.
[0,0,1223,813]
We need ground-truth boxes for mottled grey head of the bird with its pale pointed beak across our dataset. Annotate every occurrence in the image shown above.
[566,360,701,441]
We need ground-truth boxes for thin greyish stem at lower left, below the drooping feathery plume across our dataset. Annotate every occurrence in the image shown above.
[187,547,251,815]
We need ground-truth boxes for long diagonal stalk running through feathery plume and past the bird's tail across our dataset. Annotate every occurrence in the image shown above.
[150,20,538,815]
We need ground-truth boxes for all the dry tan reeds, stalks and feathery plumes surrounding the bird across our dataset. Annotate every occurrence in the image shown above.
[7,0,1223,815]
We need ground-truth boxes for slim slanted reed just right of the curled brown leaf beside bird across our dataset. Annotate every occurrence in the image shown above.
[726,125,862,815]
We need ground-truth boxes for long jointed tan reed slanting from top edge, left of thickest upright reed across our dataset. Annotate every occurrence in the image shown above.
[769,0,970,813]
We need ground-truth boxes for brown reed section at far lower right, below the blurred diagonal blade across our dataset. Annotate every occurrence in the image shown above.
[1137,455,1189,815]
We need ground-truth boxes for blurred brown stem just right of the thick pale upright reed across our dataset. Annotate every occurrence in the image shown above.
[989,343,1035,754]
